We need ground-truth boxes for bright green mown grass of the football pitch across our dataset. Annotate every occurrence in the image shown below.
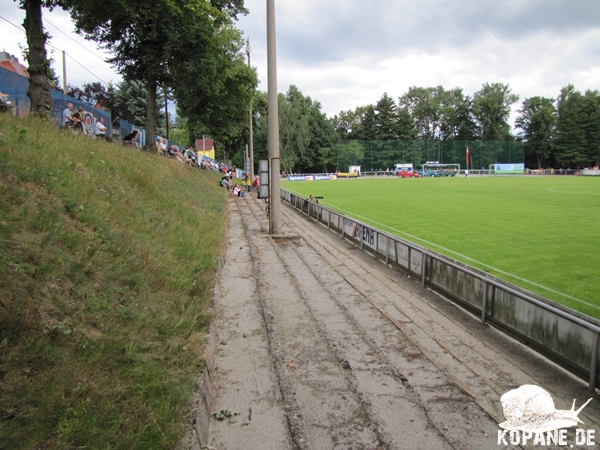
[282,176,600,318]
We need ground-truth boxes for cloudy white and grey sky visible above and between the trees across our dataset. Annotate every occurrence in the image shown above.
[0,0,600,121]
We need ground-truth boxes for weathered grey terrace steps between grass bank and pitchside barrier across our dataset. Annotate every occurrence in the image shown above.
[201,196,600,449]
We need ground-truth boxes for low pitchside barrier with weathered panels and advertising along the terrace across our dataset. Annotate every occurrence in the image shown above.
[281,190,600,391]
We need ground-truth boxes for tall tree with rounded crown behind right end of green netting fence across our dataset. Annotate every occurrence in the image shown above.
[473,83,519,141]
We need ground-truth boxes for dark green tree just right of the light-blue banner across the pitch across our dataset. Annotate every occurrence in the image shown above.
[515,97,556,168]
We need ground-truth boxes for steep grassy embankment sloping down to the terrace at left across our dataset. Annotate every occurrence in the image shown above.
[0,114,225,450]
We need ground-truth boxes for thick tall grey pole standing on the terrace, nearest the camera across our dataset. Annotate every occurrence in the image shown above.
[267,0,281,235]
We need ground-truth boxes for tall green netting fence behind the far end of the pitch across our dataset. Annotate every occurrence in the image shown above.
[336,141,525,172]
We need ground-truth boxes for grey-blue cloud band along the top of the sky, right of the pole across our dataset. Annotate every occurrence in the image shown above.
[264,0,600,65]
